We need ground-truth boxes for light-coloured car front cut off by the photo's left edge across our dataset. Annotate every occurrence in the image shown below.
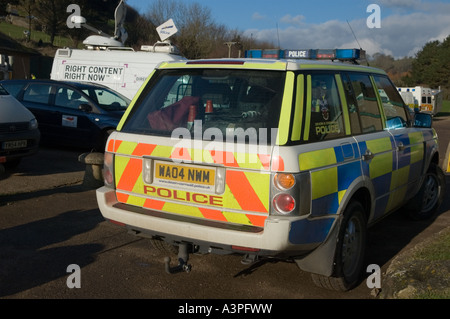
[0,85,40,167]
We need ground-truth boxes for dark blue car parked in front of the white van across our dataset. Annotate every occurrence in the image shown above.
[0,80,131,152]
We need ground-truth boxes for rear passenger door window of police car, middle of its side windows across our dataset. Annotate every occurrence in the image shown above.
[346,73,383,134]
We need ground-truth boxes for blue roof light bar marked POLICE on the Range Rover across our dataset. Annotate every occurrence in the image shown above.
[245,49,364,61]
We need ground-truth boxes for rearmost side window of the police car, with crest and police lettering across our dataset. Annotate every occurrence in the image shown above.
[304,74,345,141]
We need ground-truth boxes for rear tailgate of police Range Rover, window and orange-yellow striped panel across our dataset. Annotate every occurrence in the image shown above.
[114,65,286,231]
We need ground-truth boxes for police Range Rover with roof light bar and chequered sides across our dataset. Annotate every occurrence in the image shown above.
[97,49,445,291]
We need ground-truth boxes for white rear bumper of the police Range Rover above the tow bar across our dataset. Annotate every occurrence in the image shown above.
[96,187,334,257]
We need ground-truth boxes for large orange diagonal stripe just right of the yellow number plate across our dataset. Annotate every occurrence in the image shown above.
[226,171,267,212]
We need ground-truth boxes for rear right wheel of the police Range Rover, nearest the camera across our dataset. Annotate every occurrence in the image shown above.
[311,201,367,291]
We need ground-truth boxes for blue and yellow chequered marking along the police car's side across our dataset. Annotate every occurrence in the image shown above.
[299,131,432,222]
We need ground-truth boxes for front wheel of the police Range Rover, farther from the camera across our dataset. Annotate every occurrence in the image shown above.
[405,163,445,220]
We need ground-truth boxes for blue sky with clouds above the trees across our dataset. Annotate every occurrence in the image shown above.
[126,0,450,58]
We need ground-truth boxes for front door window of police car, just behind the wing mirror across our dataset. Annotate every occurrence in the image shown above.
[374,75,408,129]
